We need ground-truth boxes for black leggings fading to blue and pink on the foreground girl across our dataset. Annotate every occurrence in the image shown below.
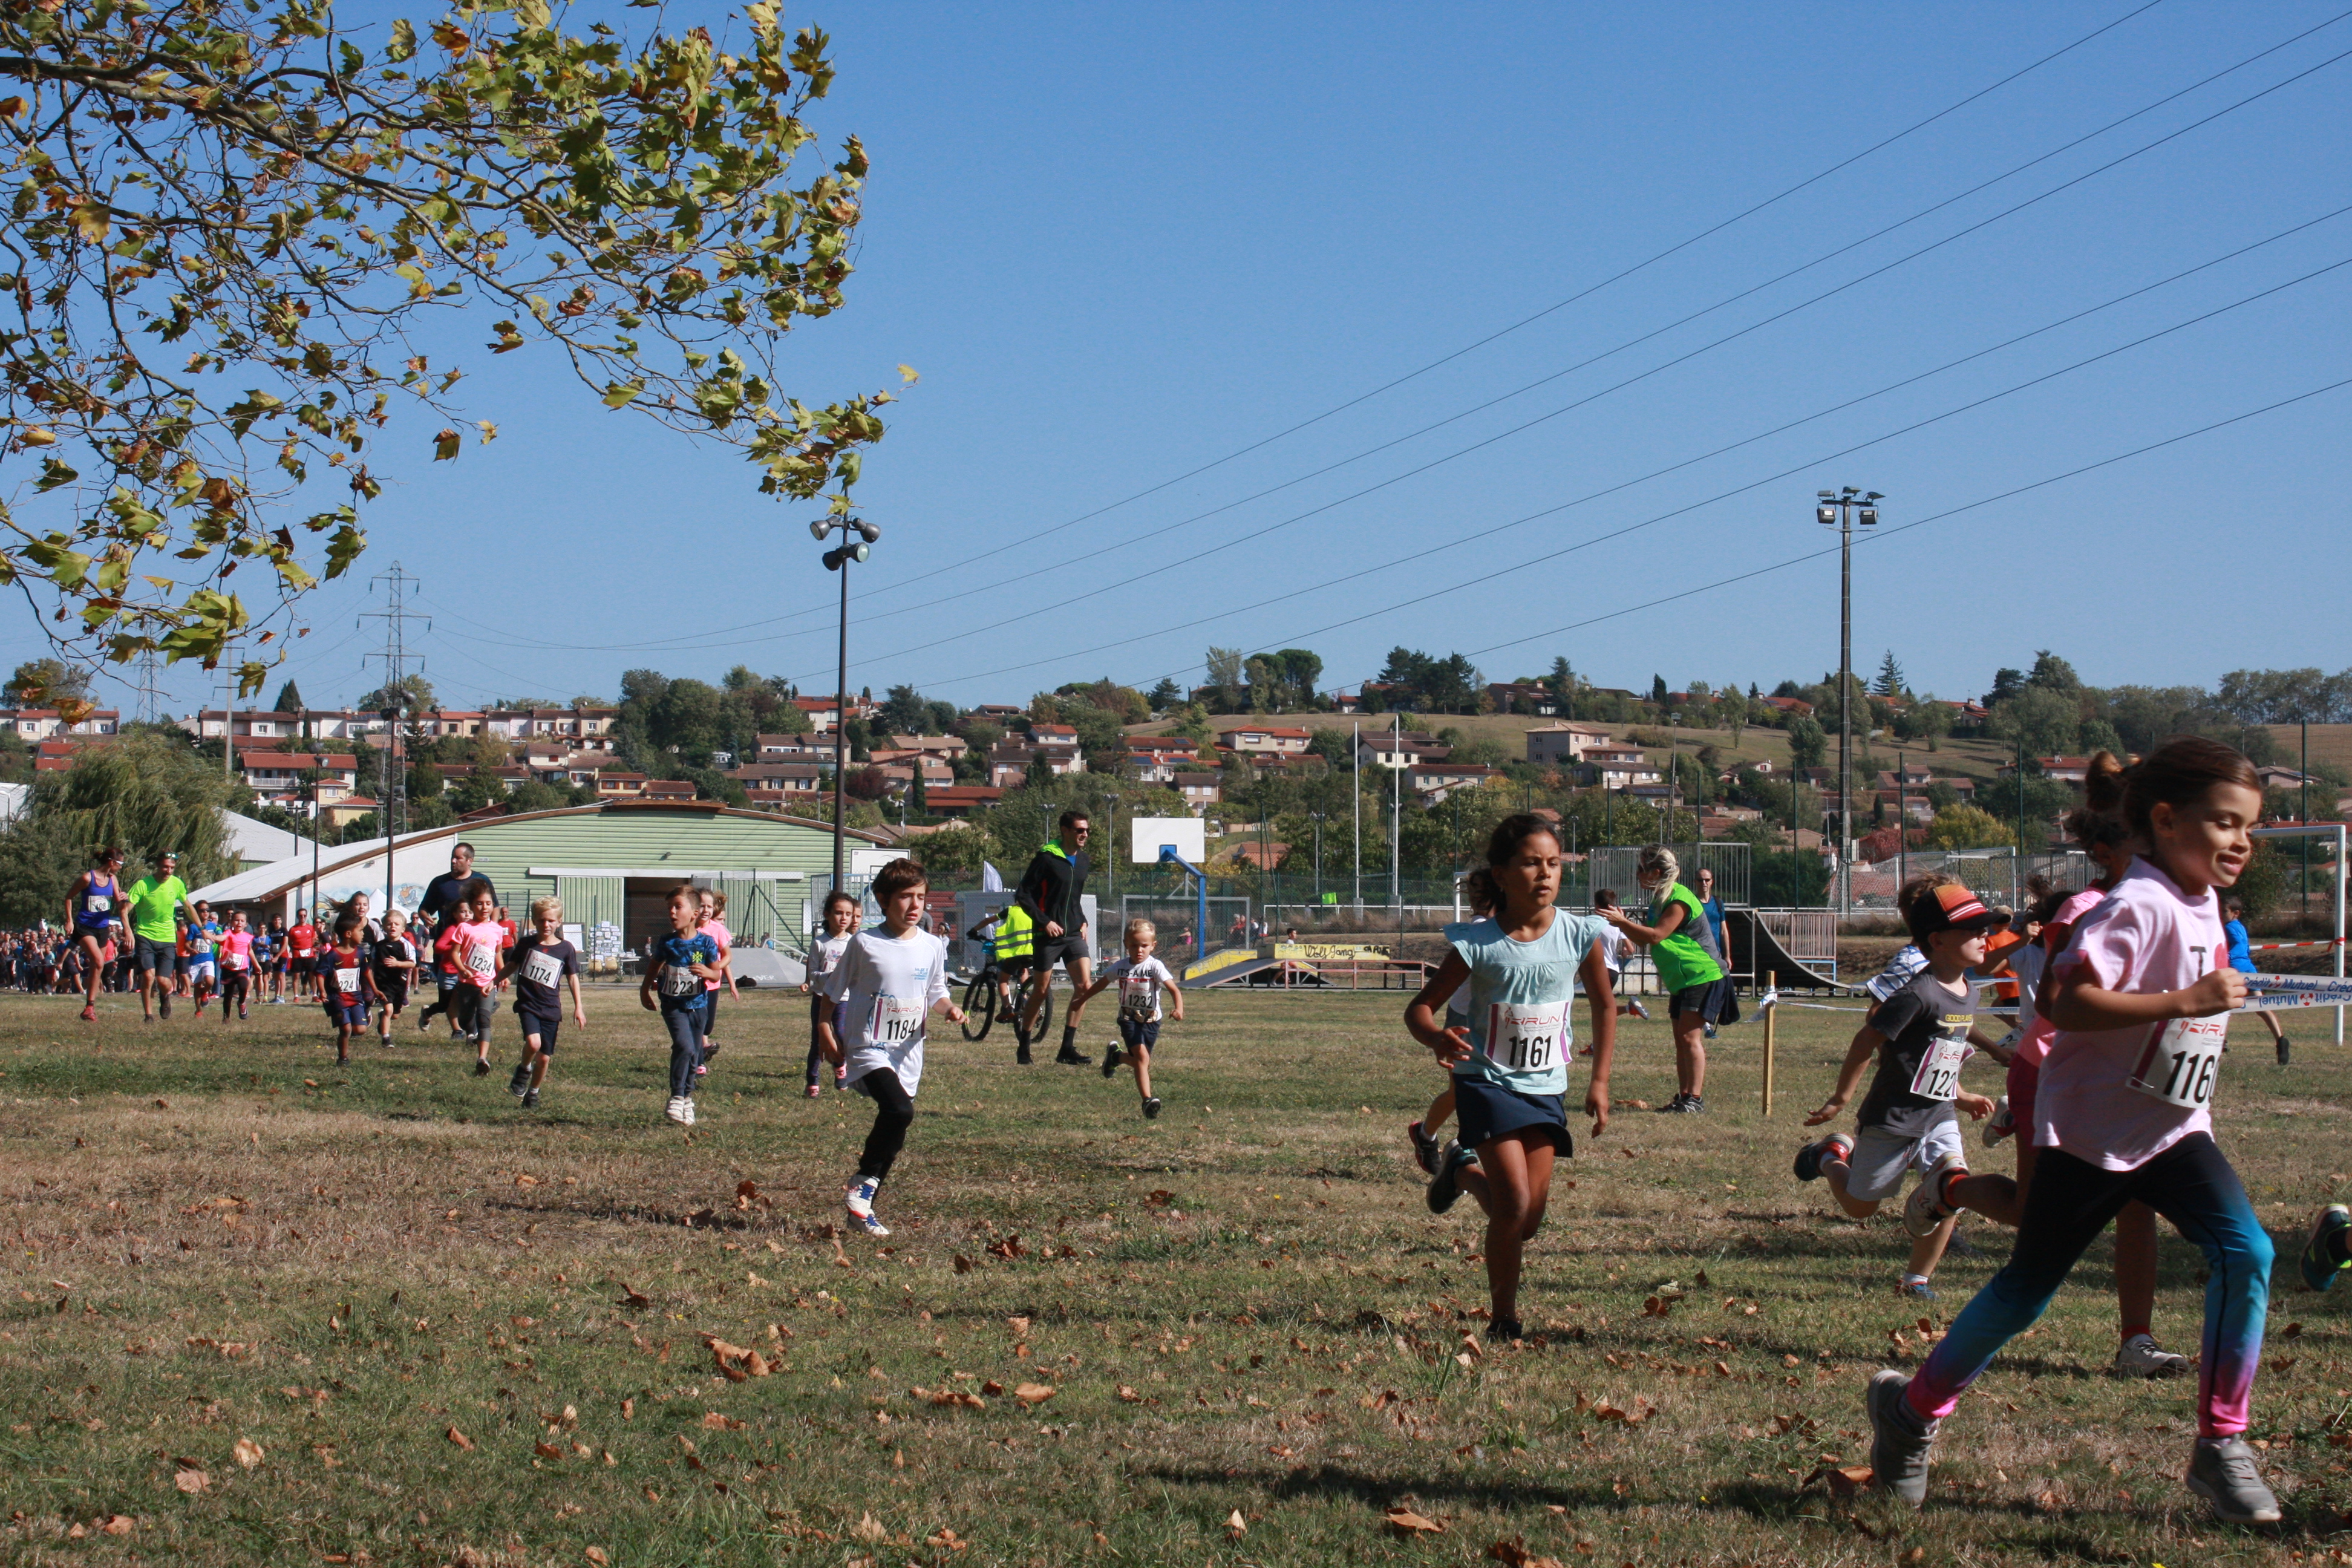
[1905,1133,2272,1436]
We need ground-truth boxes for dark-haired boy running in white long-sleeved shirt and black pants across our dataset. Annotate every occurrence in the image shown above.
[816,858,964,1236]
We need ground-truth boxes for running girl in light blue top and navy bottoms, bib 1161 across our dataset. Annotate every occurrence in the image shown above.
[1404,814,1616,1340]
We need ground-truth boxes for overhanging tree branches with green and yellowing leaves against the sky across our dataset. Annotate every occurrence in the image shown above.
[0,0,910,701]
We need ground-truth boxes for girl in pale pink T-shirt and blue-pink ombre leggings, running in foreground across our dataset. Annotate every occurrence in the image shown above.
[1865,736,2279,1523]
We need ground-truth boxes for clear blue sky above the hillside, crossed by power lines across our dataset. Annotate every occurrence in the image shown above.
[41,0,2352,710]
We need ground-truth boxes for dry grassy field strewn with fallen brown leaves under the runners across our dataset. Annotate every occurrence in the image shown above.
[0,987,2352,1568]
